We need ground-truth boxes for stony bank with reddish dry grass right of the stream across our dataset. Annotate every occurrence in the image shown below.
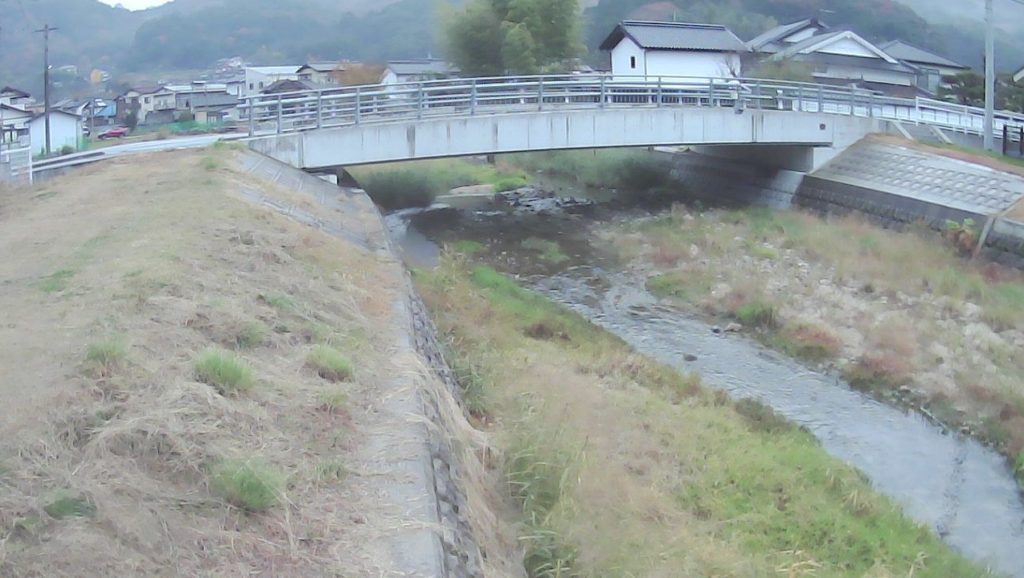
[606,207,1024,485]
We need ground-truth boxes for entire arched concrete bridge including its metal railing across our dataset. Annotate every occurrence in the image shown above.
[243,75,1024,172]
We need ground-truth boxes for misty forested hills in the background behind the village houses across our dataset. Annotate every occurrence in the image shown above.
[0,0,1024,96]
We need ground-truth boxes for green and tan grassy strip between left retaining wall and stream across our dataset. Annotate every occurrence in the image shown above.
[416,257,983,577]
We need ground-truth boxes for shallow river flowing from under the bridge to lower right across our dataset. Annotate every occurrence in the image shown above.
[387,191,1024,578]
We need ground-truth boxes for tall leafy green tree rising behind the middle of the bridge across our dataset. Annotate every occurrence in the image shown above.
[444,0,583,76]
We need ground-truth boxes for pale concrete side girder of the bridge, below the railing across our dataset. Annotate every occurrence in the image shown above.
[249,107,885,172]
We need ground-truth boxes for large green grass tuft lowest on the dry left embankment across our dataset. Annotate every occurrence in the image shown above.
[210,459,285,511]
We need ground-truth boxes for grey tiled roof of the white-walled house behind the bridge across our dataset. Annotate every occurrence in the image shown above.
[601,20,749,52]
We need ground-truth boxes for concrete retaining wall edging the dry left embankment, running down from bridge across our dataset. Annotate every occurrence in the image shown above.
[242,153,483,578]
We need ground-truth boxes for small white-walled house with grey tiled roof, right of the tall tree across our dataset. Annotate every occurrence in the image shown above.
[601,20,748,81]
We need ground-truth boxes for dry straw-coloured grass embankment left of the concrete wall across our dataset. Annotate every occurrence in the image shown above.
[0,148,430,576]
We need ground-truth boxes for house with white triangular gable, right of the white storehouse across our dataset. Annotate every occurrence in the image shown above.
[770,30,918,96]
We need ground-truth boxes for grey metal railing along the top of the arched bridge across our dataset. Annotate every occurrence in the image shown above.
[241,74,1024,137]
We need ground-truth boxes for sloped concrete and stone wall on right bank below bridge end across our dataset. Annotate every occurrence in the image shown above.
[670,138,1024,267]
